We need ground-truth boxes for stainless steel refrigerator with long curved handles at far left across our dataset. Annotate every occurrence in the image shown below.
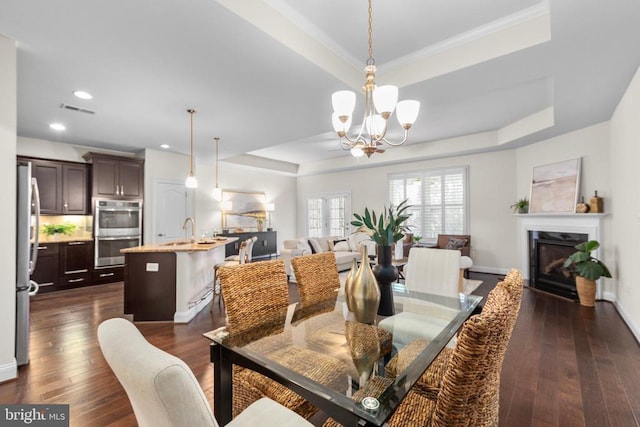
[16,162,40,366]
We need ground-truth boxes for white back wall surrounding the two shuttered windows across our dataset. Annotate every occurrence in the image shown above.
[297,150,518,273]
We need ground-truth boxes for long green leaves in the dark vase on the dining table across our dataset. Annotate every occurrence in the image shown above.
[351,200,411,246]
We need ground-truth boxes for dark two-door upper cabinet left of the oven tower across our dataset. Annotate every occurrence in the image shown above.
[21,158,90,215]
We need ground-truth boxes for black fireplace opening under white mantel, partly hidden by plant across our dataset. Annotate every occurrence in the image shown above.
[529,231,589,299]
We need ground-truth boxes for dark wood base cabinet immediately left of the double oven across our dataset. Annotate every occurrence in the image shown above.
[59,241,93,287]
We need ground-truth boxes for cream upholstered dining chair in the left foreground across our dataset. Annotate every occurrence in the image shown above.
[98,318,312,427]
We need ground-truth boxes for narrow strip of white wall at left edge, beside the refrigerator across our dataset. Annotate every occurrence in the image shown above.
[0,35,17,382]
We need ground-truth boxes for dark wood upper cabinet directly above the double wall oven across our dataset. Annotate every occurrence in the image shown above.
[84,153,144,200]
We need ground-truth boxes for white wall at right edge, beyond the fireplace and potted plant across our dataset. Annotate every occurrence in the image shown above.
[607,65,640,340]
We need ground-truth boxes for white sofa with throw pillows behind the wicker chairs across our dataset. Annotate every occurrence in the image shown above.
[280,233,376,278]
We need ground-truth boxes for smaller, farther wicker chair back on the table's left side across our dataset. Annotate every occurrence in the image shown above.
[291,252,340,305]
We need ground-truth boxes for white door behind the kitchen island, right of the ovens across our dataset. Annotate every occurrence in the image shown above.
[153,180,188,244]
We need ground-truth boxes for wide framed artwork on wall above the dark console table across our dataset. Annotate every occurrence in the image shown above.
[222,190,267,230]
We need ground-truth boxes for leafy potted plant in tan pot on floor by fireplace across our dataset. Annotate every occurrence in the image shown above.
[564,240,611,307]
